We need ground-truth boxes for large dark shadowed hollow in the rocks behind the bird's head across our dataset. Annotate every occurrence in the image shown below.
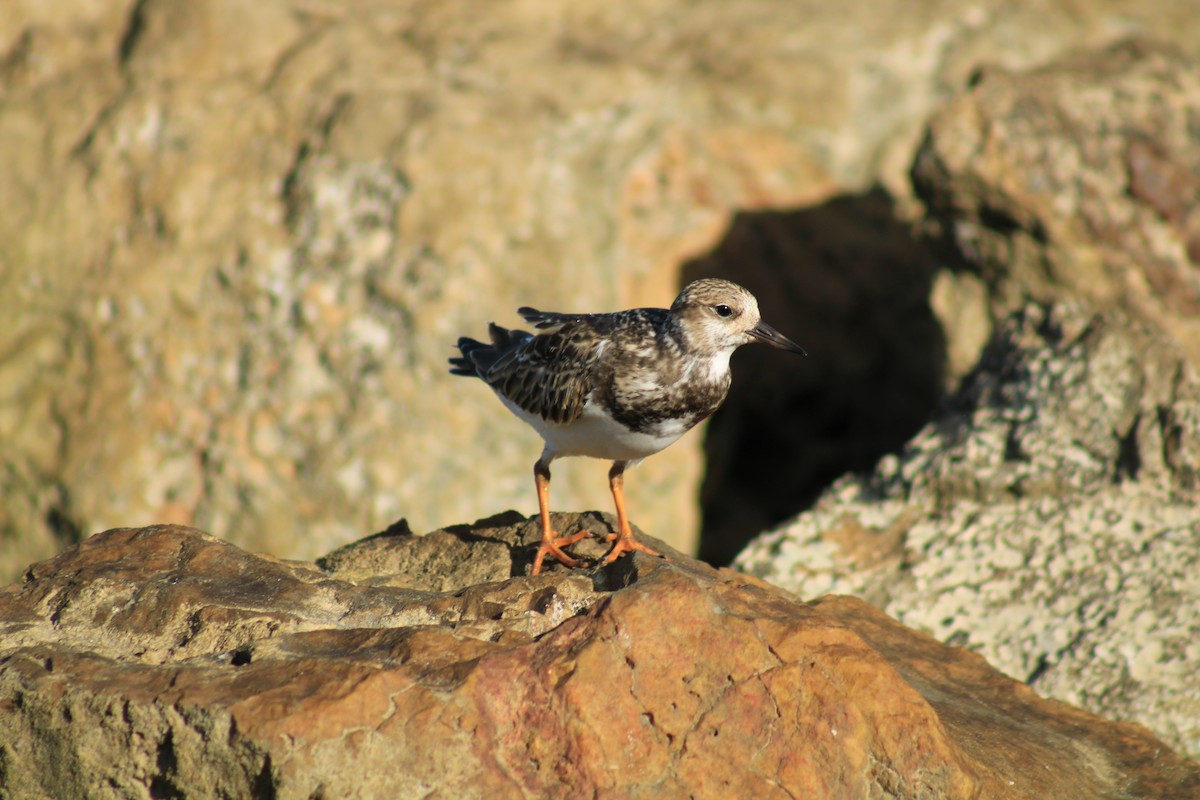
[680,188,946,565]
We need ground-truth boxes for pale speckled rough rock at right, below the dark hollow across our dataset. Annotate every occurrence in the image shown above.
[737,305,1200,754]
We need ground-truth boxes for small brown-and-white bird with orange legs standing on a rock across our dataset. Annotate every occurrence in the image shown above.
[450,278,808,575]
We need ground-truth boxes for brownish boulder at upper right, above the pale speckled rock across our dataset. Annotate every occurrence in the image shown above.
[913,40,1200,366]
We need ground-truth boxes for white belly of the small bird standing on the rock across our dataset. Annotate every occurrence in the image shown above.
[497,393,688,461]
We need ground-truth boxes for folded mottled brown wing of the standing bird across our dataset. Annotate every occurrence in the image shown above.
[484,323,602,422]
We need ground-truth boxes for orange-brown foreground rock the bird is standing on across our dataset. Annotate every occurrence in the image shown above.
[0,515,1200,800]
